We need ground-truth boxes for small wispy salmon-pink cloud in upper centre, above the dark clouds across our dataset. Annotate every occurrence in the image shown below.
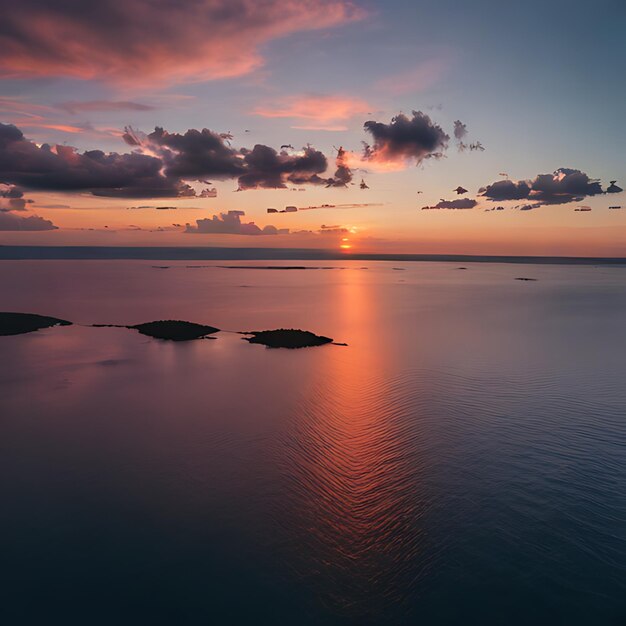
[253,95,371,123]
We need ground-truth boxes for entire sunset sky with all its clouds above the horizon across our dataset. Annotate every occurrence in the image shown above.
[0,0,626,256]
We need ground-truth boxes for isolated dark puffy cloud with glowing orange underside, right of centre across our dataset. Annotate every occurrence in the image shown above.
[364,111,450,164]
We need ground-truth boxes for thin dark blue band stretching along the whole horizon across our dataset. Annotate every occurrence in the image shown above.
[0,245,626,265]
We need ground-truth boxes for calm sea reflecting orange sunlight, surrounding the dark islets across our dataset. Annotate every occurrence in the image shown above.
[0,261,626,626]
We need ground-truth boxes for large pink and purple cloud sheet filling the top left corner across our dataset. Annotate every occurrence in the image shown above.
[0,0,365,85]
